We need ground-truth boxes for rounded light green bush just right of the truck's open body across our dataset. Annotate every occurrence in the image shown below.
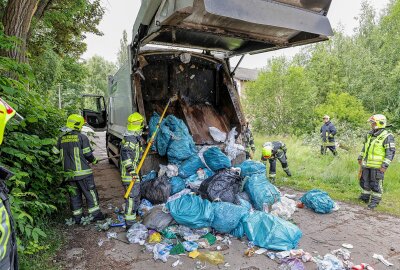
[244,58,316,134]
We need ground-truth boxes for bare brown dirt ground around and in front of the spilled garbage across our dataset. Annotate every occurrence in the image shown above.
[56,133,400,270]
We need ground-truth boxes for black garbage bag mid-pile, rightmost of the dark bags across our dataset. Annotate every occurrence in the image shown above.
[199,169,242,203]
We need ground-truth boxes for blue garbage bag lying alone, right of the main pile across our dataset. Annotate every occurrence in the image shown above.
[300,189,335,214]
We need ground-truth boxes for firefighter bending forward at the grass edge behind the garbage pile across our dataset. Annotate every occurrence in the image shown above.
[261,141,292,183]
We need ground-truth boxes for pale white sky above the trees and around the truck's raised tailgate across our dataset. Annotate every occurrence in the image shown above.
[82,0,389,68]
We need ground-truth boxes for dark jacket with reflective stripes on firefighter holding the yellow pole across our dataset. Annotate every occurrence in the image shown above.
[120,134,143,184]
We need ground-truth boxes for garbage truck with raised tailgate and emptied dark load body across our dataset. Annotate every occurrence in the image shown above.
[82,0,333,173]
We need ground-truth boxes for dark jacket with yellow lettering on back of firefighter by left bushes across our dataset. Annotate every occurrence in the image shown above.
[53,130,97,180]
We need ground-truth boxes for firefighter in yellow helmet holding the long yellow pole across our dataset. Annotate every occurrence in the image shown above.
[120,112,144,229]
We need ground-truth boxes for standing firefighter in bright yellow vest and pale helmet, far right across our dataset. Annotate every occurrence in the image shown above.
[358,114,396,209]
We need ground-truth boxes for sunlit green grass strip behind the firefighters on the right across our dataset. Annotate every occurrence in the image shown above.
[255,135,400,216]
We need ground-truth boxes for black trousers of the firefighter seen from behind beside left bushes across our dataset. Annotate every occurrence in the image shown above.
[69,174,101,221]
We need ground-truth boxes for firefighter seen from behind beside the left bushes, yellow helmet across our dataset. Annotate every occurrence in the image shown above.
[53,114,106,224]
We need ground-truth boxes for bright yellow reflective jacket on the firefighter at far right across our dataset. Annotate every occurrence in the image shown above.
[358,129,396,169]
